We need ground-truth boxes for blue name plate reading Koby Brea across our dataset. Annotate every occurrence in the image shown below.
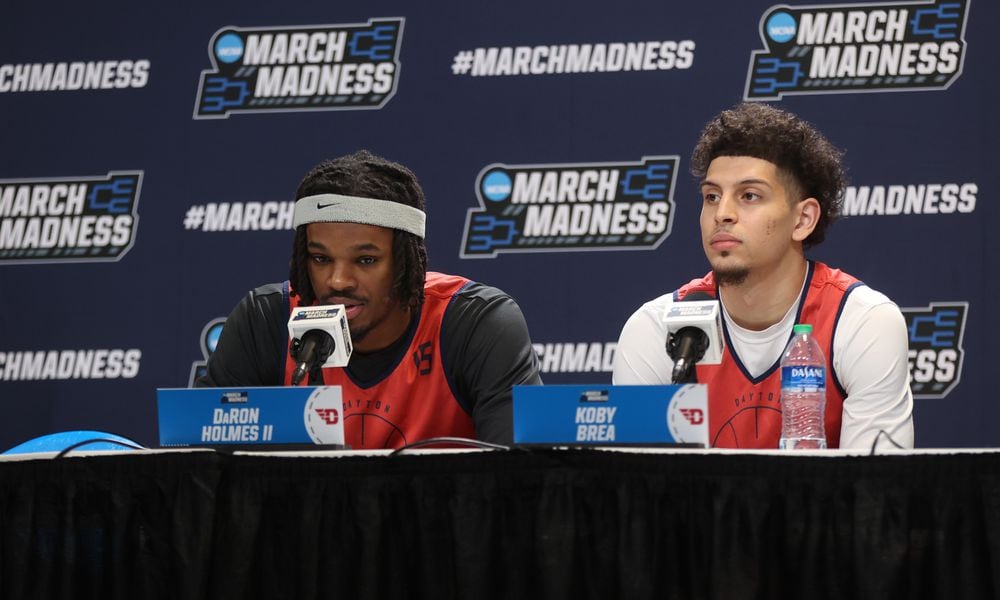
[514,384,708,447]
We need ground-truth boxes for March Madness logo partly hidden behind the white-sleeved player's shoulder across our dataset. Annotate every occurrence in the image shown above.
[902,302,969,398]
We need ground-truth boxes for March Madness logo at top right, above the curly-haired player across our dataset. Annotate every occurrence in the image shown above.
[744,0,968,100]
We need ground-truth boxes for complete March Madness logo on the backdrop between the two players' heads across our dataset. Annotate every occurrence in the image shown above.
[461,156,678,258]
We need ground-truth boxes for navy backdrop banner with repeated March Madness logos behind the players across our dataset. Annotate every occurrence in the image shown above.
[0,0,1000,449]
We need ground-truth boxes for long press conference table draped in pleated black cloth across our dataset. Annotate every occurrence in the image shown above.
[0,449,1000,600]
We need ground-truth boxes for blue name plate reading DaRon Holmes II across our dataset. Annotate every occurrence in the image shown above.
[156,386,344,446]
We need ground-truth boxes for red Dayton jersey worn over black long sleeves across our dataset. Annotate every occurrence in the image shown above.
[285,273,475,449]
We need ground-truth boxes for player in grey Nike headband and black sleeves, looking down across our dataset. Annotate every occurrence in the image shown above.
[198,151,541,448]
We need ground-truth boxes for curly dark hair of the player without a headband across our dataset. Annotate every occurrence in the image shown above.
[691,102,847,248]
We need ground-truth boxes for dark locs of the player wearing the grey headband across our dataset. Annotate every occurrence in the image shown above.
[288,150,427,308]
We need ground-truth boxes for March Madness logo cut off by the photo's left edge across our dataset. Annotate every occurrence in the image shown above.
[0,171,142,264]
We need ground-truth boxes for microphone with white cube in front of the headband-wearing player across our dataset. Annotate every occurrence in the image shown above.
[288,304,352,385]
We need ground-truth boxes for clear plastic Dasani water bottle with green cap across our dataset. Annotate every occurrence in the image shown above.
[778,324,826,450]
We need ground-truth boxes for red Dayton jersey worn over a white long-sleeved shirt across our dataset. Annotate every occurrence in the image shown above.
[675,262,860,448]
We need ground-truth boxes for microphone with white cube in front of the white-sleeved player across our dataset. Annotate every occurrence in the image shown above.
[663,292,725,383]
